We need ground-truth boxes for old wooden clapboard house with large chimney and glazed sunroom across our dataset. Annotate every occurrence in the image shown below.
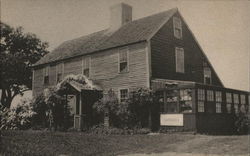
[33,3,250,131]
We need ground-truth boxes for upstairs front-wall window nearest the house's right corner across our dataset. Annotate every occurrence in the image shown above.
[119,48,128,73]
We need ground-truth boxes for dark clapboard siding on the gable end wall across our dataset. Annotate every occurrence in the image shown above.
[151,13,222,86]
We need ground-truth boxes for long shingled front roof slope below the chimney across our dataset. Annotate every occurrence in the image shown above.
[34,8,177,66]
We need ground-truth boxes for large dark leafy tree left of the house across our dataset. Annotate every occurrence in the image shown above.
[0,22,48,108]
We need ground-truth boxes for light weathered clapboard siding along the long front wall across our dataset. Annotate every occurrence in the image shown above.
[33,42,149,96]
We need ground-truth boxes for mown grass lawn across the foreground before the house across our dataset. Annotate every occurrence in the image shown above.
[0,131,250,156]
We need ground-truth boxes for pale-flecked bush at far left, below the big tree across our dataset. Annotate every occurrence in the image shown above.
[0,99,35,130]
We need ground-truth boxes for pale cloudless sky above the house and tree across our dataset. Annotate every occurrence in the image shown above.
[1,0,250,106]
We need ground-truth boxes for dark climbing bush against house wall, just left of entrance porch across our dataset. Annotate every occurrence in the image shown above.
[33,88,71,130]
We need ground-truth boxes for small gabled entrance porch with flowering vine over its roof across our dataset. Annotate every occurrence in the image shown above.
[58,75,102,130]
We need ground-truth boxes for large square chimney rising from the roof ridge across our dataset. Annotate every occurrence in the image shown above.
[110,3,132,31]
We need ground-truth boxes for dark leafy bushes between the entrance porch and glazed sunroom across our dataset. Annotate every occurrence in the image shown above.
[93,88,154,129]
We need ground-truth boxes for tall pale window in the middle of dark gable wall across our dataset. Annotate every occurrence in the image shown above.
[175,47,185,73]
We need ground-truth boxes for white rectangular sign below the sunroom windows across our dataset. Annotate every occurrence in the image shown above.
[160,114,183,126]
